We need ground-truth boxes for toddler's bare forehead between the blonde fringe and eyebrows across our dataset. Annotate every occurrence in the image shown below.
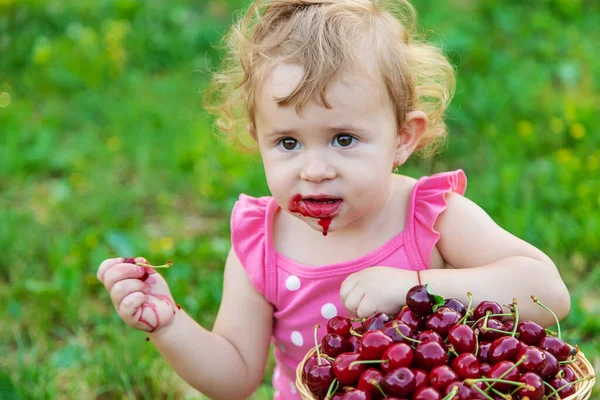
[257,63,390,122]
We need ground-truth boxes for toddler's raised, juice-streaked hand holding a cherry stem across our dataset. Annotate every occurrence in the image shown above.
[97,257,178,332]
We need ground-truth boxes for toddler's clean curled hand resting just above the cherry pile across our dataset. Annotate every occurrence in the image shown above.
[340,267,419,318]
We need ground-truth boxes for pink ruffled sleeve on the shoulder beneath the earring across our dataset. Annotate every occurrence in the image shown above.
[407,169,467,269]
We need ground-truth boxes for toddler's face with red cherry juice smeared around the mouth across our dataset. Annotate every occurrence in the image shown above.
[256,63,399,232]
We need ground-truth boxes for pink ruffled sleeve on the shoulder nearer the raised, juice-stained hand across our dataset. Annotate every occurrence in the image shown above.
[231,194,269,295]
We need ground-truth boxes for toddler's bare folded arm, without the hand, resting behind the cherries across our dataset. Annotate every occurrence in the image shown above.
[421,193,570,326]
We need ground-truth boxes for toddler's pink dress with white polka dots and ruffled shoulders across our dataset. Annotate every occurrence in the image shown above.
[231,170,466,400]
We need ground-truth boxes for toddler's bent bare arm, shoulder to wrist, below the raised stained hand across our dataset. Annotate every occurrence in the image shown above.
[149,250,273,400]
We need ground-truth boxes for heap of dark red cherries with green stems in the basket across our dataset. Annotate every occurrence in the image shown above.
[302,285,592,400]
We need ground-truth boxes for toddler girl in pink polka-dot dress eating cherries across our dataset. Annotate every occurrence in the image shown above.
[98,0,569,400]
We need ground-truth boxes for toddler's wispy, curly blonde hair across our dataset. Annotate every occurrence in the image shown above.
[204,0,455,156]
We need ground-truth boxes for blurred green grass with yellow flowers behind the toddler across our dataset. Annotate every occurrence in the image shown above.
[0,0,600,399]
